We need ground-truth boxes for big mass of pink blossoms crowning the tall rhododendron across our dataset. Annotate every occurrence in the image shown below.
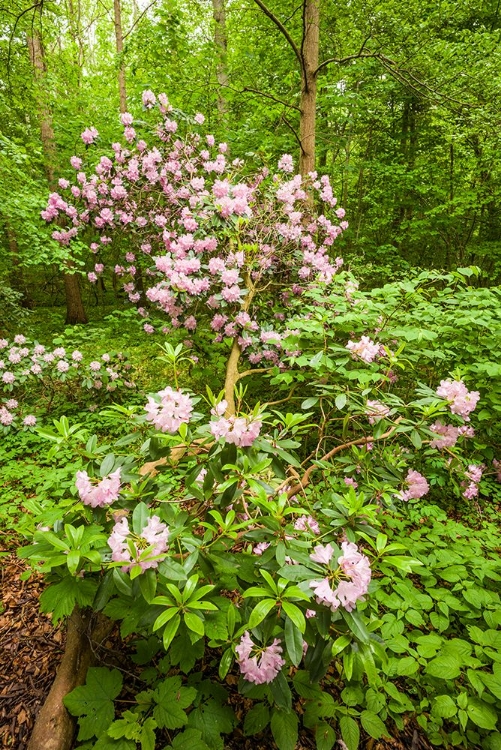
[42,91,348,365]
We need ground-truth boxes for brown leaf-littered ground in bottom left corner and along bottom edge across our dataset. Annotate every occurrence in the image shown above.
[0,551,431,750]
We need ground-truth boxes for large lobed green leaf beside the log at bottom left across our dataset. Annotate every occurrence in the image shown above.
[63,667,122,740]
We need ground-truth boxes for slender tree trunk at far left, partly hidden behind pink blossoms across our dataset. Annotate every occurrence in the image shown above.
[28,10,88,325]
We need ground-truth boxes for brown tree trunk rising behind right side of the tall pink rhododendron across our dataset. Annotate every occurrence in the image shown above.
[299,0,320,176]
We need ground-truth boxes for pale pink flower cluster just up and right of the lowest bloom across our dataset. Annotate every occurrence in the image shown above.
[310,542,371,612]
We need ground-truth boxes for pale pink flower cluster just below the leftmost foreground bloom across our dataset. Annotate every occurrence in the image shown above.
[108,516,169,571]
